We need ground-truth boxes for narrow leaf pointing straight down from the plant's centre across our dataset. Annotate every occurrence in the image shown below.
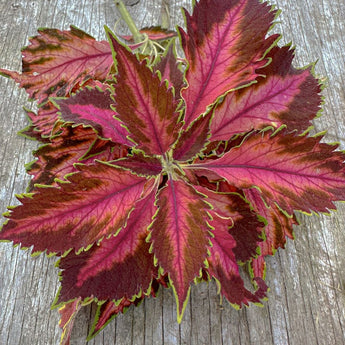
[150,178,210,322]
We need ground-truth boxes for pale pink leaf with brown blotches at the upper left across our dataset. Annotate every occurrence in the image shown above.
[0,26,113,103]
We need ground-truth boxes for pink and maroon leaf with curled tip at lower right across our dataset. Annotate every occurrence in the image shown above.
[208,216,267,307]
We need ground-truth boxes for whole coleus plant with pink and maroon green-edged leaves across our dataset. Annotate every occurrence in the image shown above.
[0,0,345,344]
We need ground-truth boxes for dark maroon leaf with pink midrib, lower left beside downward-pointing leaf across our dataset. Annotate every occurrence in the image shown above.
[58,190,158,303]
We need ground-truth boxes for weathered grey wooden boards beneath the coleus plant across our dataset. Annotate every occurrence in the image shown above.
[0,0,345,345]
